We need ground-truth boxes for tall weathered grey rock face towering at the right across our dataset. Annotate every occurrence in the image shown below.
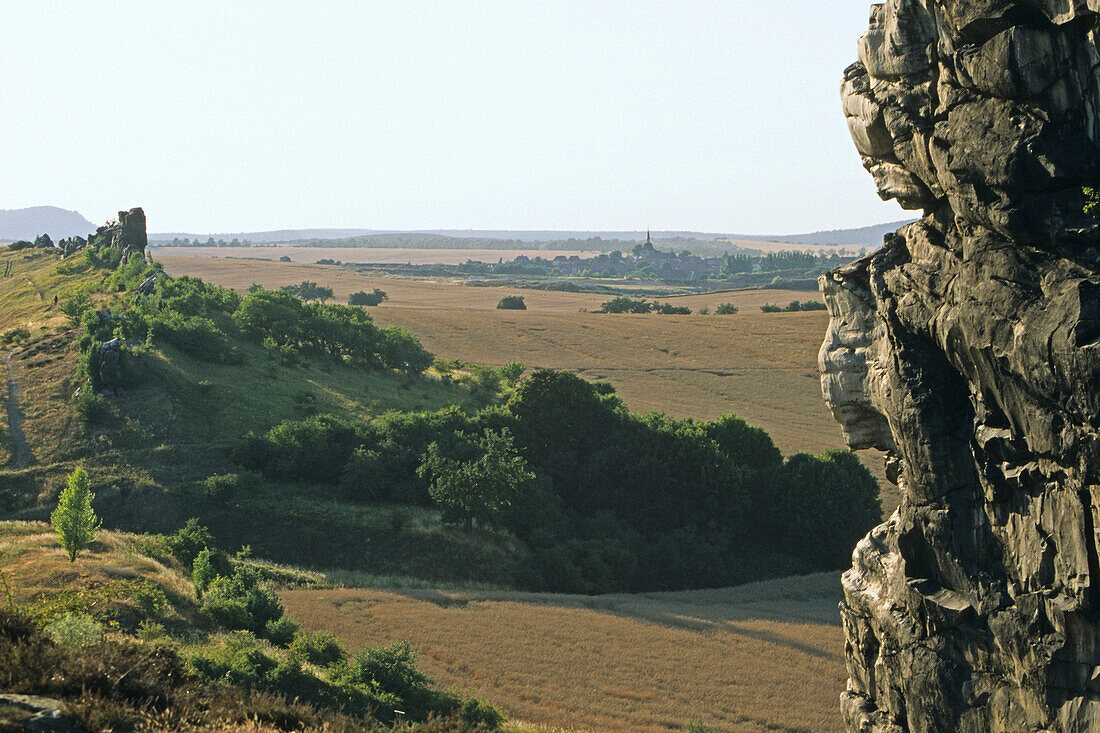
[820,0,1100,732]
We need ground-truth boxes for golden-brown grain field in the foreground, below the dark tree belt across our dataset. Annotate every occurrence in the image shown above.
[282,573,845,733]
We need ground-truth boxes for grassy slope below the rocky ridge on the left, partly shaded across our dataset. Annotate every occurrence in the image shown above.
[0,252,519,578]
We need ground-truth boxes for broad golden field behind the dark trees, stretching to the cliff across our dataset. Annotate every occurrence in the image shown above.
[161,256,897,497]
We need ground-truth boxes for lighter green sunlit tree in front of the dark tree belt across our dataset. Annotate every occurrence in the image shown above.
[417,428,535,533]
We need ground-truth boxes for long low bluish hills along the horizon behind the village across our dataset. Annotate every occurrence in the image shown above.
[149,220,909,249]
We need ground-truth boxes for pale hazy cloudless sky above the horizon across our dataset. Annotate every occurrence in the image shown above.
[0,0,904,233]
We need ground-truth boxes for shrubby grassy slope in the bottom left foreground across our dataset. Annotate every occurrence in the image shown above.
[0,522,502,733]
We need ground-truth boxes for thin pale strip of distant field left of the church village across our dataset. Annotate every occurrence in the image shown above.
[149,245,600,264]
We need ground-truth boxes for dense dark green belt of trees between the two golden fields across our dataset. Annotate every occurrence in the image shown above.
[234,371,880,593]
